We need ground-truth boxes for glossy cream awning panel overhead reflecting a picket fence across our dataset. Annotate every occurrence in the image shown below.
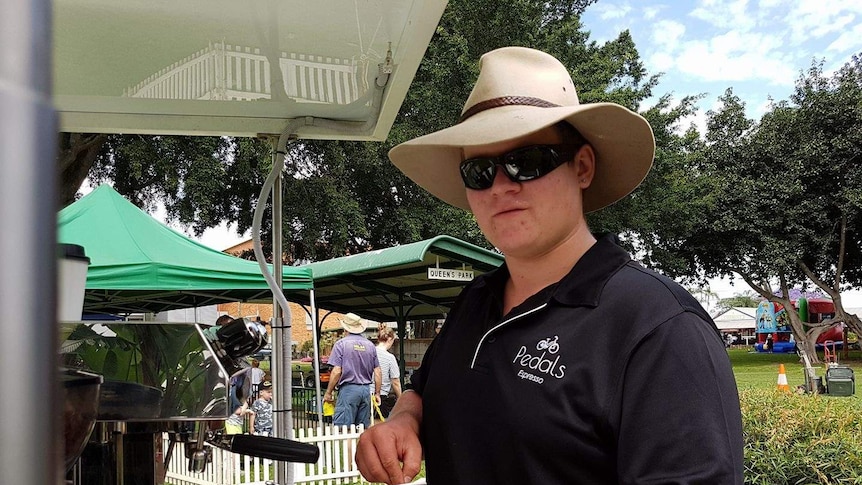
[53,0,447,140]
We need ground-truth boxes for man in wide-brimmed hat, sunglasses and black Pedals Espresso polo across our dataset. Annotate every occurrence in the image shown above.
[356,47,743,485]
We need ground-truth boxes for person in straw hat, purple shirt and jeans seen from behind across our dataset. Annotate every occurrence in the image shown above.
[323,313,382,428]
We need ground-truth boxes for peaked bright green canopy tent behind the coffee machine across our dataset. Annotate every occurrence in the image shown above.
[57,185,312,313]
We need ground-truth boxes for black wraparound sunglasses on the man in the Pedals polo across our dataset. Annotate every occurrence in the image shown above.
[461,145,581,190]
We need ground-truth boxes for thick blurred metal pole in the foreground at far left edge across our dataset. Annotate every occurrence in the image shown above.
[0,0,60,484]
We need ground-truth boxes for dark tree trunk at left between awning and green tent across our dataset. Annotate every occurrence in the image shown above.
[57,133,108,208]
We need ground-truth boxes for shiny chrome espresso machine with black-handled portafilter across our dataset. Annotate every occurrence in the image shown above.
[60,318,320,485]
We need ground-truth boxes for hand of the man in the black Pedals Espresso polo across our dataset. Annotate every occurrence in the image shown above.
[356,392,422,485]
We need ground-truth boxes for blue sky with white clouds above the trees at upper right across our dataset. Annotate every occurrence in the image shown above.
[582,0,862,132]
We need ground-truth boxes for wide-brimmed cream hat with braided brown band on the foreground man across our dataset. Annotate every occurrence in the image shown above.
[389,47,655,212]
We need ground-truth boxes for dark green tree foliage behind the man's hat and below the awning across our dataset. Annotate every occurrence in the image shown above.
[61,0,676,262]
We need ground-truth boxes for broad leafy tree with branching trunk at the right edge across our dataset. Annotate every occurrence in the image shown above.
[639,54,862,362]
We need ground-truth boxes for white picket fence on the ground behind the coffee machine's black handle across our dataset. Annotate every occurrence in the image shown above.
[165,425,367,485]
